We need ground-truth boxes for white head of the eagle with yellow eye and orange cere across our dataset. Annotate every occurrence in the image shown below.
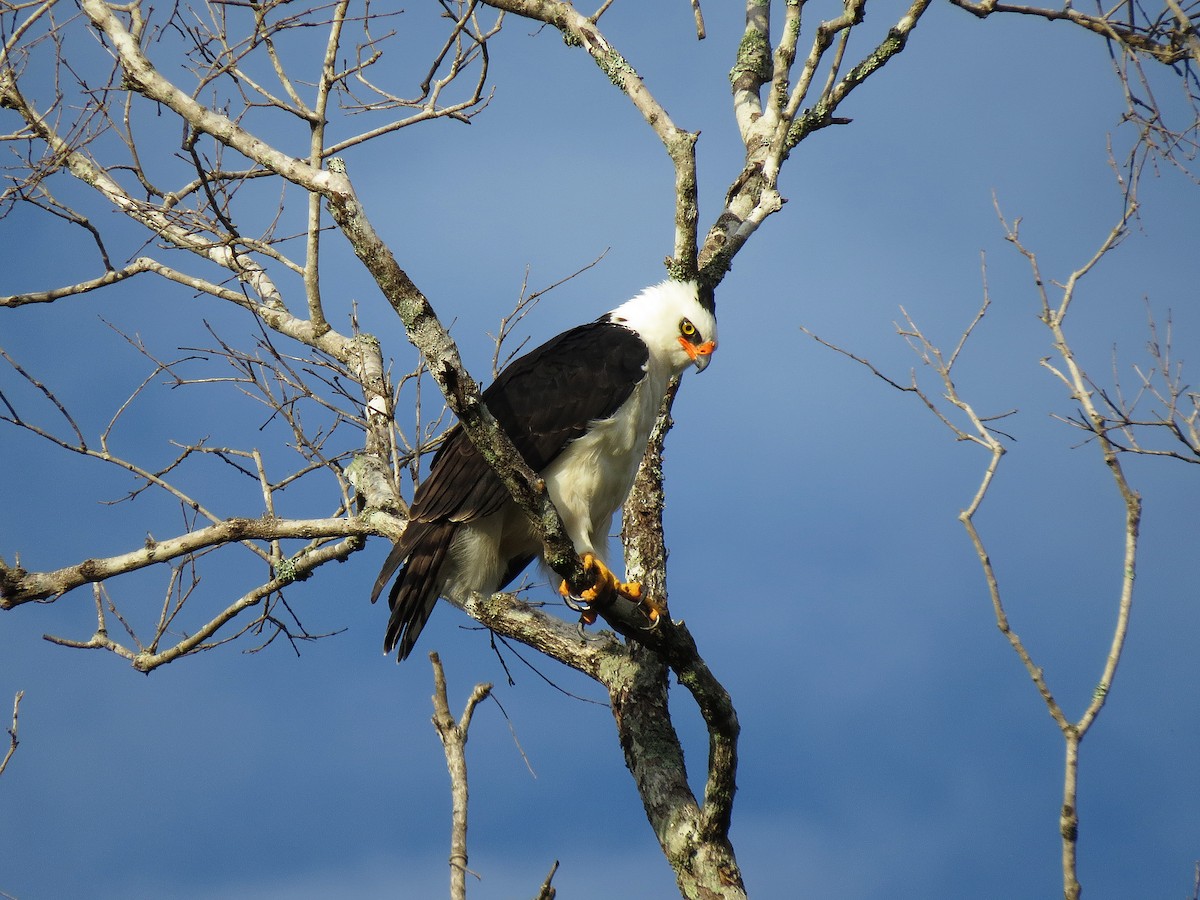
[605,281,716,374]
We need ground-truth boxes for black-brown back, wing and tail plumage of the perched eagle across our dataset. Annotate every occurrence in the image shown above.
[371,320,649,659]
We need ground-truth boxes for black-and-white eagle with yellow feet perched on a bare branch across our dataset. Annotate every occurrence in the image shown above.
[371,281,716,660]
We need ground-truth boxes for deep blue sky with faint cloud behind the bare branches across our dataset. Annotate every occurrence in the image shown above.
[0,4,1200,900]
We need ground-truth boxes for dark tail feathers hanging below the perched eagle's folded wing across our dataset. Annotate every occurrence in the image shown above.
[371,522,457,661]
